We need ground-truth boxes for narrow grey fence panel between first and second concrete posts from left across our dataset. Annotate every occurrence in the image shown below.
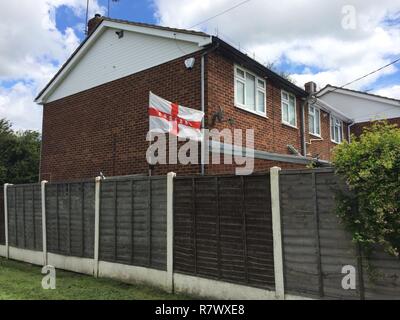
[7,184,42,251]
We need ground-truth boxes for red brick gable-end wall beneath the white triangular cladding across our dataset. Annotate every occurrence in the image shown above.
[41,55,205,181]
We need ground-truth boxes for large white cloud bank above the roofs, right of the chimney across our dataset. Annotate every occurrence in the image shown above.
[154,0,400,89]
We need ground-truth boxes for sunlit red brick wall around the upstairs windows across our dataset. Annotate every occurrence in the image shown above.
[207,52,301,154]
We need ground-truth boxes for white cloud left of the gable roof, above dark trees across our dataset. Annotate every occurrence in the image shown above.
[0,0,104,129]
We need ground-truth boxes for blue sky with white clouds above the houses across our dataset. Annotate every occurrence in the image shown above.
[0,0,400,131]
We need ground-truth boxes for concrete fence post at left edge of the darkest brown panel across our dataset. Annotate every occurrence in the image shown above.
[167,172,176,292]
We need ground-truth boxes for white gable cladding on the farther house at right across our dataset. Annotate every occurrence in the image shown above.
[320,92,400,123]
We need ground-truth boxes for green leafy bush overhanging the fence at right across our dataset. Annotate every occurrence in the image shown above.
[333,122,400,256]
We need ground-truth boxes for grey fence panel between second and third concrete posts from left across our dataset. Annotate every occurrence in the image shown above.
[46,181,95,258]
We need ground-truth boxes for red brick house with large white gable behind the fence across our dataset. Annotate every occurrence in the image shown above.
[35,15,348,181]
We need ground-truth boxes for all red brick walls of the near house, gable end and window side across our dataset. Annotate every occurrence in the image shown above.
[41,48,310,181]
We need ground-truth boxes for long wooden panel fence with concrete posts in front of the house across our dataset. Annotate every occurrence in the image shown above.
[0,169,400,299]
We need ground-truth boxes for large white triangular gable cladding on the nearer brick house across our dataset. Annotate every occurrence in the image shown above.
[46,28,202,102]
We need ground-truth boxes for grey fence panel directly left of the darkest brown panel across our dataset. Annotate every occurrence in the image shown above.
[100,177,167,270]
